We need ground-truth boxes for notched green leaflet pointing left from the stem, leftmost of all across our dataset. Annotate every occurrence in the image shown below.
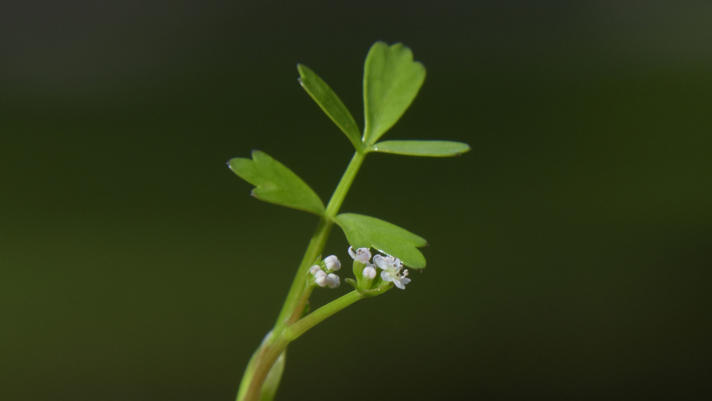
[228,150,324,216]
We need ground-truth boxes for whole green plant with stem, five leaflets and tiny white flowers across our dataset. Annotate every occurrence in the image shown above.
[228,42,470,401]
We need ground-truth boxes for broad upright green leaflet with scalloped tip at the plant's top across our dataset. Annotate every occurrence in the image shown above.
[363,42,425,145]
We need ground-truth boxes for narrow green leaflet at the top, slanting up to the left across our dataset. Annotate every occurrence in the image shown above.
[297,64,362,149]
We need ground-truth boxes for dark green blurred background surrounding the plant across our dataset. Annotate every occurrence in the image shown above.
[0,0,712,401]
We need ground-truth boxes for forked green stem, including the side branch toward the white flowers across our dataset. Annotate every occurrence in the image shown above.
[237,151,366,401]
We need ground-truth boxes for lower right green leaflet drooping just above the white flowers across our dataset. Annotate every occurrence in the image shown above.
[335,213,427,269]
